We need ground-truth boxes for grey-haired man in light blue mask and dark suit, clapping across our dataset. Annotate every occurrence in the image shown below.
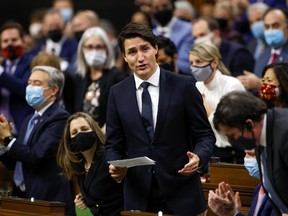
[0,66,75,216]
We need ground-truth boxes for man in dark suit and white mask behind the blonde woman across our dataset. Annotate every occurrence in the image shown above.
[192,18,255,77]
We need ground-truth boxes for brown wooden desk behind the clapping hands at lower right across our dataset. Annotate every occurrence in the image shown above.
[203,163,260,216]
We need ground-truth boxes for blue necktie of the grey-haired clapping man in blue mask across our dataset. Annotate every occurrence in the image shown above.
[14,113,40,186]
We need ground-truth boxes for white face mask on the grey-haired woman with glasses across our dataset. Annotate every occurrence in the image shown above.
[84,50,107,67]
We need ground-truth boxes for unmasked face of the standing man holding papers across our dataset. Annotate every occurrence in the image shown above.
[124,37,158,80]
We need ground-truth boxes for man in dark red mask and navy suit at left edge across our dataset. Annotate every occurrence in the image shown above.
[0,22,33,135]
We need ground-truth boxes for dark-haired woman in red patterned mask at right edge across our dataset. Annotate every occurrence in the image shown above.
[259,63,288,108]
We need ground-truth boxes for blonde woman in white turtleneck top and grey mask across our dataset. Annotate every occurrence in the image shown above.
[189,43,245,163]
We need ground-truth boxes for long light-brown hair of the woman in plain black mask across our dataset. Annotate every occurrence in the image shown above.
[57,112,106,179]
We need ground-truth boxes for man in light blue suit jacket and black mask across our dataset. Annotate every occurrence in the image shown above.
[152,0,193,74]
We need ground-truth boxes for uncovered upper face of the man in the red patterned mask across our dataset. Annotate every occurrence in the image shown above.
[1,29,24,49]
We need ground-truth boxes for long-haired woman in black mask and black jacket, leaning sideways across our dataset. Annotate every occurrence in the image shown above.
[57,112,123,216]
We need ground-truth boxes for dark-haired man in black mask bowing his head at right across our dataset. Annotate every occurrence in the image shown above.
[213,91,288,215]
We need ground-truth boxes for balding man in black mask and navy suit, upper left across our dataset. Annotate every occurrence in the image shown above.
[31,9,77,74]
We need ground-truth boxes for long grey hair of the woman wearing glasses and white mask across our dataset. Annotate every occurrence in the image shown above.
[77,27,115,77]
